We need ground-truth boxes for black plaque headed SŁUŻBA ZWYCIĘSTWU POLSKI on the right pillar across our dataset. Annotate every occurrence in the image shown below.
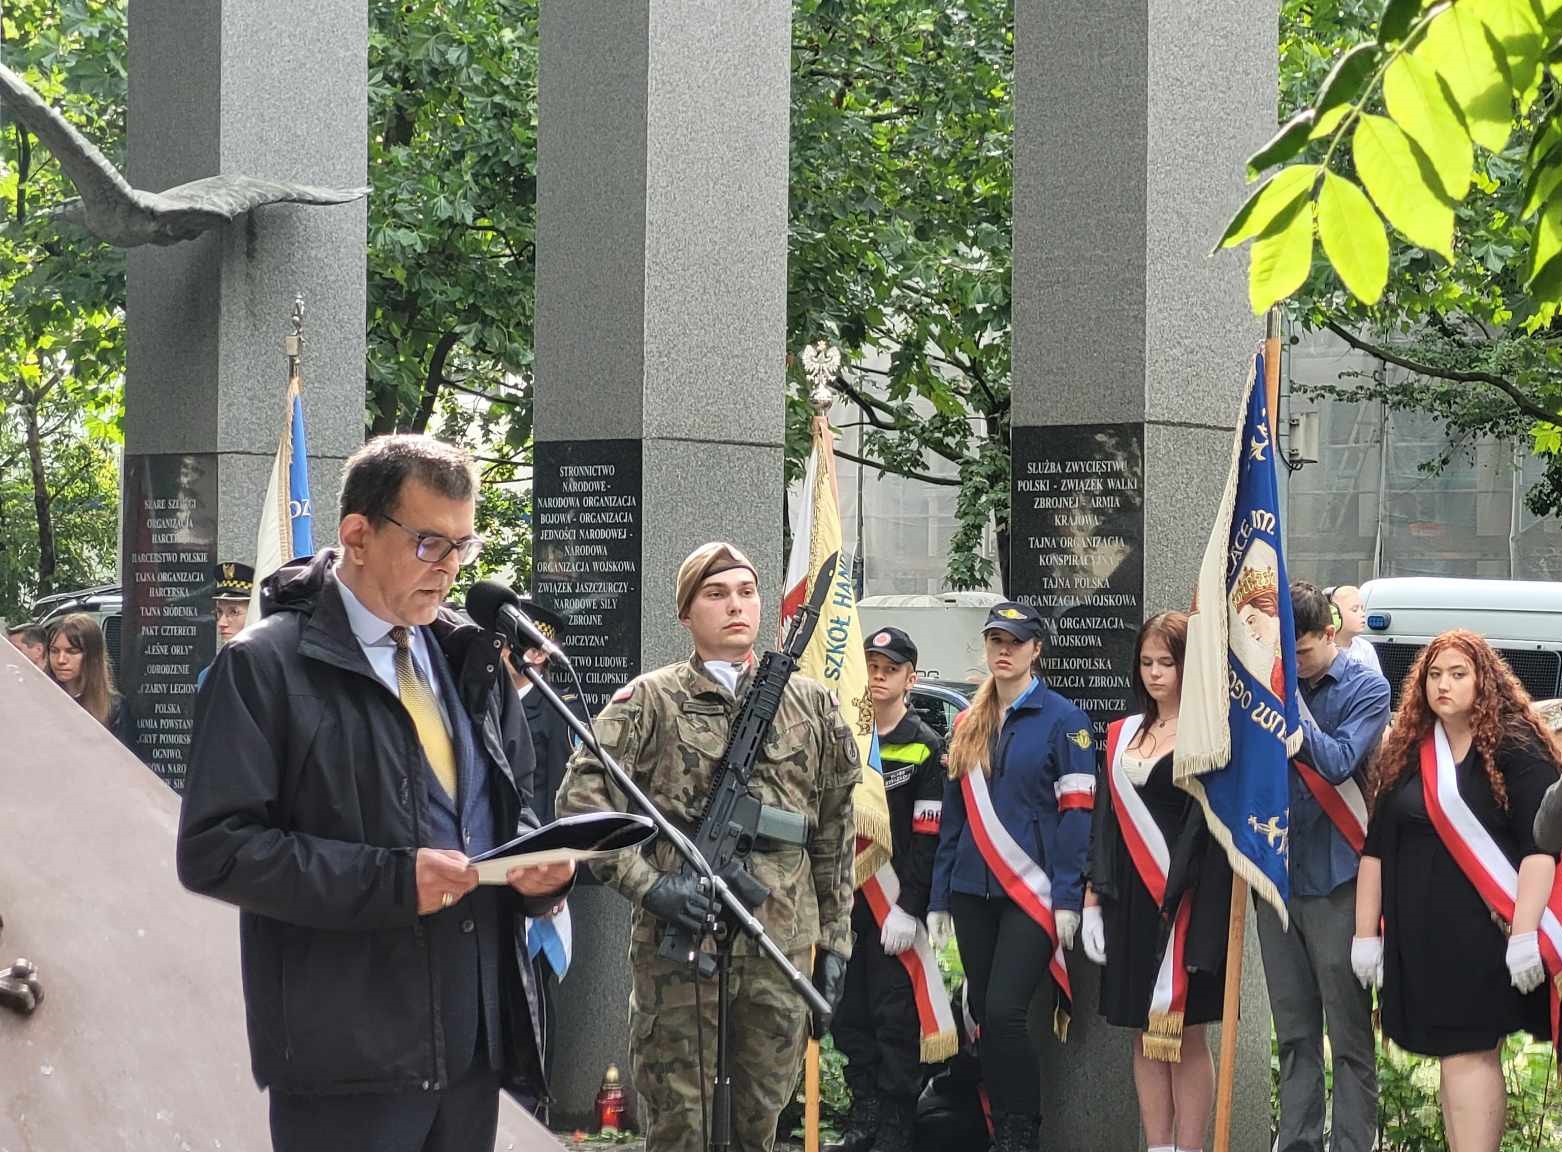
[1009,423,1145,741]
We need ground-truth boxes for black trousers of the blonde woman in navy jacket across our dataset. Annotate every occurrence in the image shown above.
[950,893,1053,1116]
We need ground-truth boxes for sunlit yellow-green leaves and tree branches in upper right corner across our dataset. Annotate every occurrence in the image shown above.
[1262,0,1562,515]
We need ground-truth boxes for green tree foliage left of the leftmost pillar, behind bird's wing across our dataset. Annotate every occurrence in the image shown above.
[0,0,125,618]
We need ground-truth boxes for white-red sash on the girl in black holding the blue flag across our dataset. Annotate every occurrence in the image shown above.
[1106,715,1193,1063]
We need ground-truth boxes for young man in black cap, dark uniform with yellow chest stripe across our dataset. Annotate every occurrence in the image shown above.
[831,628,943,1152]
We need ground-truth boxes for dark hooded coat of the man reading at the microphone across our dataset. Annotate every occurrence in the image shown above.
[178,551,556,1099]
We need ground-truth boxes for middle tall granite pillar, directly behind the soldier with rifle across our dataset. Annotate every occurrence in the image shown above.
[534,0,790,1122]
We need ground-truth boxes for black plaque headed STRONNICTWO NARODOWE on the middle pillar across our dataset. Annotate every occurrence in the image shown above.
[531,440,640,715]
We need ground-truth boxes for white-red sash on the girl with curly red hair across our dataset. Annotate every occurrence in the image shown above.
[1421,723,1562,1044]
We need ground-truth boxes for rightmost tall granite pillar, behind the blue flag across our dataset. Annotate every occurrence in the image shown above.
[1011,0,1278,1152]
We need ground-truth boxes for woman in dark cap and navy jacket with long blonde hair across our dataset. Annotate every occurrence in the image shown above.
[928,601,1095,1152]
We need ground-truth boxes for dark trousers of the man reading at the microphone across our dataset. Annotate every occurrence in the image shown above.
[270,1055,498,1152]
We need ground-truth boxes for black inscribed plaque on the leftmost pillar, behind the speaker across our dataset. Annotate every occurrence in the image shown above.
[120,454,217,791]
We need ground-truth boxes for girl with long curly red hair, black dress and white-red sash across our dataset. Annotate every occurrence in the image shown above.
[1351,629,1562,1152]
